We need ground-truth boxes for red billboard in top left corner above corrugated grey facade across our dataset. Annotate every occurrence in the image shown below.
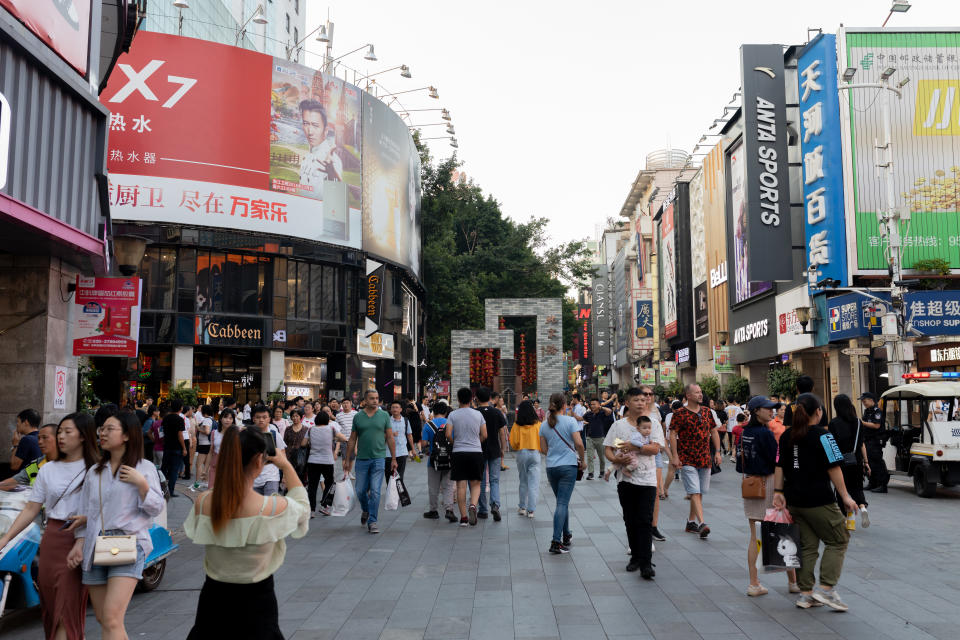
[0,0,90,76]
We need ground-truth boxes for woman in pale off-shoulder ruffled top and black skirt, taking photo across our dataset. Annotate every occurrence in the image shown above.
[183,427,310,640]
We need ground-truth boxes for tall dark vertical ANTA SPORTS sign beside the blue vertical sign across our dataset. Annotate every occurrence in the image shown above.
[740,44,793,280]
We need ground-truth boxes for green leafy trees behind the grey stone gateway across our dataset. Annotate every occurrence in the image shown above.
[417,139,592,377]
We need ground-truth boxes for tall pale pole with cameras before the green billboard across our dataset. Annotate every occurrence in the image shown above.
[840,67,910,386]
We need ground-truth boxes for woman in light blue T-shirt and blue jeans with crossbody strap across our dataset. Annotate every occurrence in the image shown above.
[540,393,586,553]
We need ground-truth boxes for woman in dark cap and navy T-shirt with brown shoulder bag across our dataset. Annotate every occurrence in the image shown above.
[735,396,800,596]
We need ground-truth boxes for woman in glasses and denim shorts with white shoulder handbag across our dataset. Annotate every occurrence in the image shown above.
[67,410,164,640]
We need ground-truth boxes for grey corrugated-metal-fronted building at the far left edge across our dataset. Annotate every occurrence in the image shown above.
[0,1,136,464]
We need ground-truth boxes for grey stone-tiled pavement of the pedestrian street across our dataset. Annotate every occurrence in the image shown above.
[2,457,960,640]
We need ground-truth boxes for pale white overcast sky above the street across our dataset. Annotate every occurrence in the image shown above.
[306,0,960,248]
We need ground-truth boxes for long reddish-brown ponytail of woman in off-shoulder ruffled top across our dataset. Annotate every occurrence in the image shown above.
[210,426,267,533]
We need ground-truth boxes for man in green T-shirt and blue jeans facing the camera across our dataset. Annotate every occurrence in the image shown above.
[343,389,397,533]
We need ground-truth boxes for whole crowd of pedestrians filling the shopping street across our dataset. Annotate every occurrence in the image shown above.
[0,376,889,638]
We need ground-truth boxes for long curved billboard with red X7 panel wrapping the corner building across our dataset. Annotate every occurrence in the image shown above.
[101,32,420,275]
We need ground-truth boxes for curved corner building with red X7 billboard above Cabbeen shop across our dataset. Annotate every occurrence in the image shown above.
[95,33,423,401]
